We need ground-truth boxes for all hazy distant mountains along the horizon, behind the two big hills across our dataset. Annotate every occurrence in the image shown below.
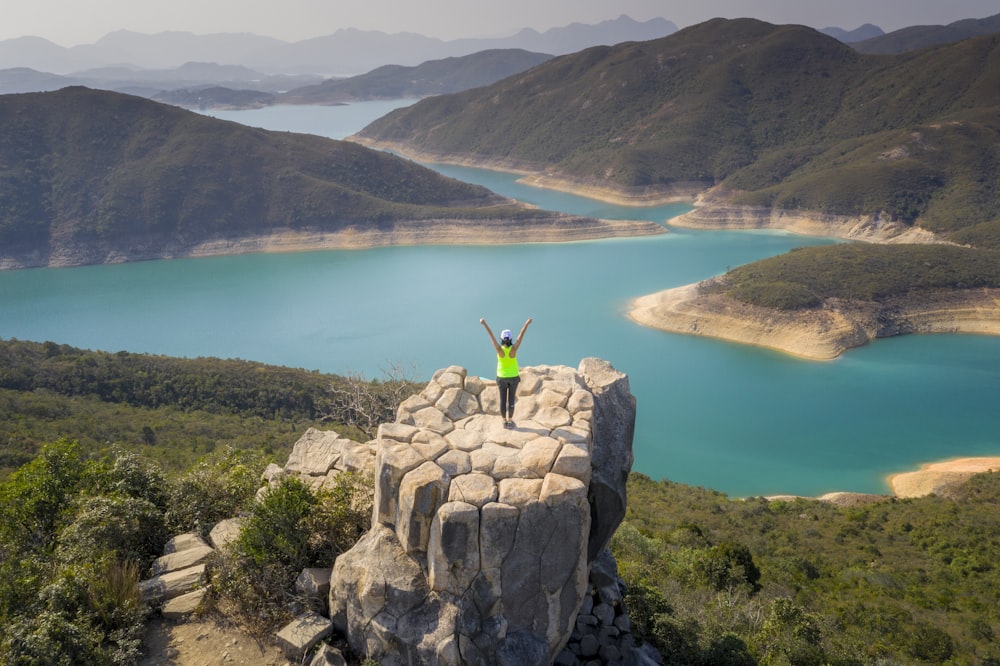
[0,15,1000,108]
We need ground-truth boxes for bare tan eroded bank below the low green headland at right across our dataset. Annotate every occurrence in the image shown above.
[629,281,1000,360]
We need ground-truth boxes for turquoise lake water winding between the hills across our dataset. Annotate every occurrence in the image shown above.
[0,102,1000,496]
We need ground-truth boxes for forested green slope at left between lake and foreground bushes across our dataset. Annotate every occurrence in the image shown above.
[0,340,421,478]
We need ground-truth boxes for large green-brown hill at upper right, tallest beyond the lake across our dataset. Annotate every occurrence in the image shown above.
[358,19,1000,236]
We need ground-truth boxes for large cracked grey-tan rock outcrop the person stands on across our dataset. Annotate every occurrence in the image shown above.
[332,359,635,666]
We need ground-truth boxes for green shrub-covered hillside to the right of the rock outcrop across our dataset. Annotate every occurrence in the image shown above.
[612,474,1000,666]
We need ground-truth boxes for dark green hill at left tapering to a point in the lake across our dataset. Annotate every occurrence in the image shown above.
[0,88,584,267]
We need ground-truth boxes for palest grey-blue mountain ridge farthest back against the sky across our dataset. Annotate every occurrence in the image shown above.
[0,15,677,77]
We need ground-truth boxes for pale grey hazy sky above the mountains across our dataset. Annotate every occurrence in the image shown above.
[0,0,1000,46]
